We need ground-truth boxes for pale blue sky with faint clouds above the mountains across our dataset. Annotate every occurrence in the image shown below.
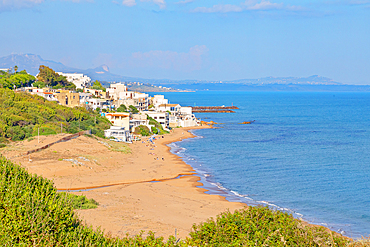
[0,0,370,85]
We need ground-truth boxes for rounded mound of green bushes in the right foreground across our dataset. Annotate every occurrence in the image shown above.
[187,207,348,246]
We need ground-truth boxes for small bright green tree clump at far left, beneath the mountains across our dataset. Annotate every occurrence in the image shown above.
[0,67,36,89]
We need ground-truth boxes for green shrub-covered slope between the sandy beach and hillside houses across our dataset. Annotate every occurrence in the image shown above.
[0,88,111,143]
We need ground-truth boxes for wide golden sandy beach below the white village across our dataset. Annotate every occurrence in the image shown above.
[2,126,246,238]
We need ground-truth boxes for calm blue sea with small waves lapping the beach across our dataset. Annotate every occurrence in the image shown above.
[151,91,370,239]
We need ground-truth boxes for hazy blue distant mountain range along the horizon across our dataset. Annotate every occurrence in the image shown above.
[0,54,370,91]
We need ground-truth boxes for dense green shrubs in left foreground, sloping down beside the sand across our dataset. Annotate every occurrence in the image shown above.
[0,157,174,246]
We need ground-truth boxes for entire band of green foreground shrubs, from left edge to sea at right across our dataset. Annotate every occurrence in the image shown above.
[0,157,358,246]
